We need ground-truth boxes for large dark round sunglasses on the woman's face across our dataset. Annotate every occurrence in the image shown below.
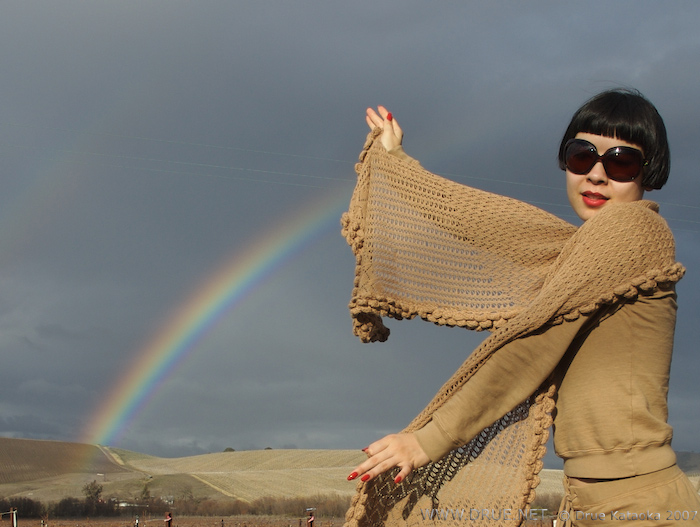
[564,139,649,182]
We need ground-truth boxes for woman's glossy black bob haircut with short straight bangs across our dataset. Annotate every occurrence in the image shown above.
[559,89,671,189]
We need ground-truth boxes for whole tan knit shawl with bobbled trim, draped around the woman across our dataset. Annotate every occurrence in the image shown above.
[342,129,684,527]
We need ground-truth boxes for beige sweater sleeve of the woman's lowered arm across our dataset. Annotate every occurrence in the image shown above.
[414,315,595,461]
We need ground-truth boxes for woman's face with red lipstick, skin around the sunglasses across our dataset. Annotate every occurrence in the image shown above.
[566,133,644,221]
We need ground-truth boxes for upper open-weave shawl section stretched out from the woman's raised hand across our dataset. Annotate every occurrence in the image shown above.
[345,128,575,340]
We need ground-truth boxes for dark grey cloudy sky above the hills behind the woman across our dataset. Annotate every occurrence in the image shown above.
[0,0,700,466]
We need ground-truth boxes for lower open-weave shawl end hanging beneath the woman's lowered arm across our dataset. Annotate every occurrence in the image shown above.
[346,389,554,527]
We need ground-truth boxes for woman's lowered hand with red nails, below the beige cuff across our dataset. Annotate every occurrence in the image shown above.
[348,436,430,483]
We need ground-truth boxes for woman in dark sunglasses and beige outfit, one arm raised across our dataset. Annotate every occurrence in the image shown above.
[345,90,700,525]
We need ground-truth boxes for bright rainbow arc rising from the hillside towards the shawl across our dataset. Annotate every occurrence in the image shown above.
[79,188,348,445]
